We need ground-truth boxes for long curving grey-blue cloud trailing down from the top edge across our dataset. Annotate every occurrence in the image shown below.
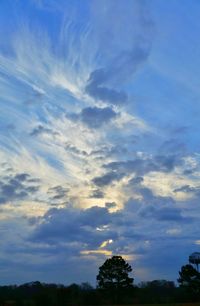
[85,1,153,105]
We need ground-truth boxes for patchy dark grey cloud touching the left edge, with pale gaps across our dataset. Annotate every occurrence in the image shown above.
[0,173,39,204]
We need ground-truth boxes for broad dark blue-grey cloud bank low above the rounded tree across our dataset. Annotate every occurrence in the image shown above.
[30,189,191,253]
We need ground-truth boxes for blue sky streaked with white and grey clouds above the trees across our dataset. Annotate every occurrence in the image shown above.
[0,0,200,285]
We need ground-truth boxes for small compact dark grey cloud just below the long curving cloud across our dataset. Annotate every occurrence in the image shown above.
[80,107,117,129]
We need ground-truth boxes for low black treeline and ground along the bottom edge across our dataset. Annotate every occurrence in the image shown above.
[0,280,200,306]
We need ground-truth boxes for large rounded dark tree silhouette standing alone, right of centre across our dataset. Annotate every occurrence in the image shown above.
[97,256,133,289]
